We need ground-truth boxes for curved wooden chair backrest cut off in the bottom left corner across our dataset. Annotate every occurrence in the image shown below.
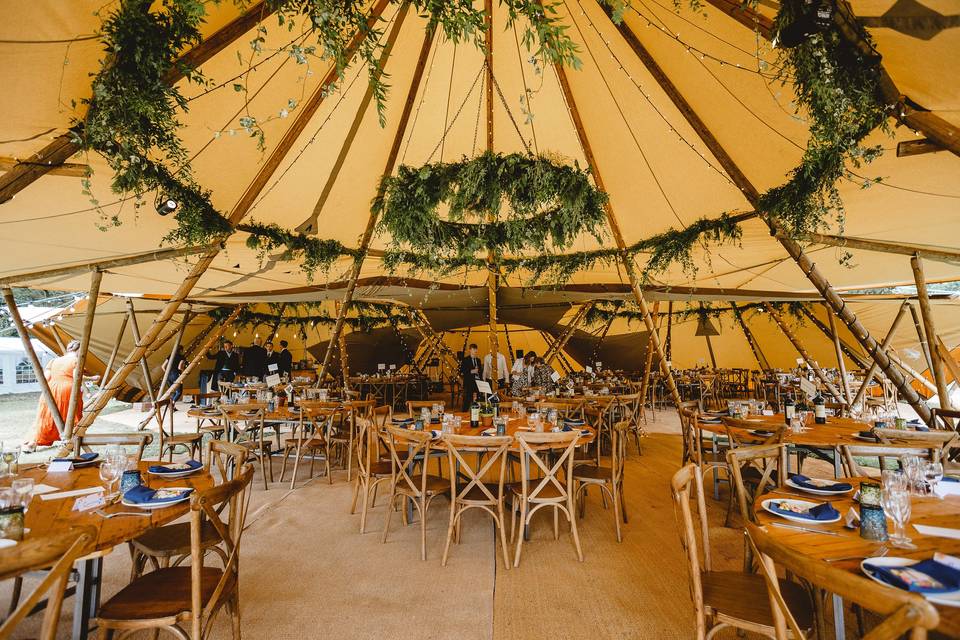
[0,528,96,640]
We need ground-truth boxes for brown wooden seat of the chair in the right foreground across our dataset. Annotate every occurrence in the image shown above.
[702,571,813,629]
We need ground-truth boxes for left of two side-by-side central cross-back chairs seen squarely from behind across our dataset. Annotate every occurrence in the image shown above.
[441,433,513,569]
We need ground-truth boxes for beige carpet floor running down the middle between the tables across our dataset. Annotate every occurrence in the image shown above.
[0,412,780,640]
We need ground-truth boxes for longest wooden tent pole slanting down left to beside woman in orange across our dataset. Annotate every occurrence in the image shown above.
[67,5,389,438]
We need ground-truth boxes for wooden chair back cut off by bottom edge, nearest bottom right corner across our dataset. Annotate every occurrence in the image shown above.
[747,523,940,640]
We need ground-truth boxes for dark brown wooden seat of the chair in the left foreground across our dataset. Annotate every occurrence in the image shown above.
[98,567,232,621]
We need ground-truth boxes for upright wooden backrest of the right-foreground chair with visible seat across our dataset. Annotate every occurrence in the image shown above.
[670,463,713,618]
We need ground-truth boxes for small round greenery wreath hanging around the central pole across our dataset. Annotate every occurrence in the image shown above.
[373,152,607,264]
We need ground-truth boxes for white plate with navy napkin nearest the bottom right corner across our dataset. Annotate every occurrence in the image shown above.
[860,554,960,607]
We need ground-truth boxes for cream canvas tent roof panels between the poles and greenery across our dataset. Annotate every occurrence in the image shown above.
[0,0,960,301]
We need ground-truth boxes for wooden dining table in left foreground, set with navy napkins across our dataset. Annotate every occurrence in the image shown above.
[20,461,214,640]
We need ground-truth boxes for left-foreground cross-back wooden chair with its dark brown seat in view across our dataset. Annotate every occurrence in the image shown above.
[97,463,253,640]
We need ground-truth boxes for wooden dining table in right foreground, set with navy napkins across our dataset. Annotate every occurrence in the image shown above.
[753,478,960,640]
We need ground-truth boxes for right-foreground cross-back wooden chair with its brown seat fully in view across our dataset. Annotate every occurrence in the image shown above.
[671,464,814,640]
